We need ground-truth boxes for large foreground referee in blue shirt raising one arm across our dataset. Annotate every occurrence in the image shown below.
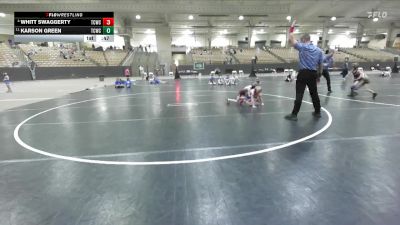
[285,21,324,121]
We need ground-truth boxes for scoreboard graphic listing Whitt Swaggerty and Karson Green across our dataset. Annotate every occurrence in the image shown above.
[14,12,114,42]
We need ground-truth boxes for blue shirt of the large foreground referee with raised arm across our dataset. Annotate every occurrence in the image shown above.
[294,42,324,70]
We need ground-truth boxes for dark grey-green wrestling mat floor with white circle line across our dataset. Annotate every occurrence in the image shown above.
[0,73,400,225]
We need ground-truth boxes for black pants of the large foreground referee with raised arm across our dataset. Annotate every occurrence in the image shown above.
[292,70,321,115]
